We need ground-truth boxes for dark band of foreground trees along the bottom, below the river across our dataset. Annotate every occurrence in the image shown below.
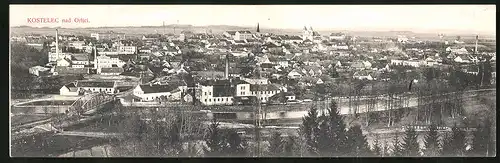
[112,103,496,157]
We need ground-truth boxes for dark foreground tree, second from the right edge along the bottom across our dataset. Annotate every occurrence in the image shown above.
[442,126,465,157]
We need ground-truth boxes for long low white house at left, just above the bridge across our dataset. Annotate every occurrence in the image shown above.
[76,81,116,94]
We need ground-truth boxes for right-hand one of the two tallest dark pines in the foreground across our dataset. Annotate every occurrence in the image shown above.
[327,102,346,156]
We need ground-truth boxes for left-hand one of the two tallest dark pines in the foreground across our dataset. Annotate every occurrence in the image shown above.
[300,106,319,155]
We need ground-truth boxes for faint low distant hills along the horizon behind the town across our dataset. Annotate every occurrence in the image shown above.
[11,24,496,40]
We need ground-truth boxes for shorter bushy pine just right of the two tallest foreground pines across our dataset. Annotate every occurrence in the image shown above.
[345,125,373,157]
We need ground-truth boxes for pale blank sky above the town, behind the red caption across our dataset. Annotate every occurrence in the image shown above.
[9,5,496,34]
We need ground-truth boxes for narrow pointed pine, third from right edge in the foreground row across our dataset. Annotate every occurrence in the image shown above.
[424,124,441,157]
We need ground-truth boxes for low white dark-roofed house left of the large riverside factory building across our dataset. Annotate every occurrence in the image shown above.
[133,84,187,101]
